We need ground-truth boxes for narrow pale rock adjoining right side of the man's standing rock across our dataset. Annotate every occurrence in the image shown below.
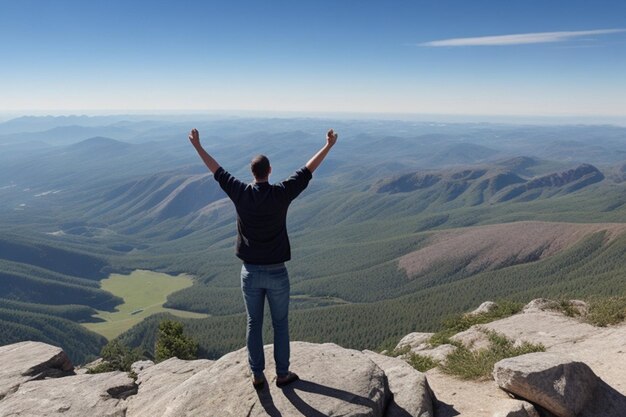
[363,350,435,417]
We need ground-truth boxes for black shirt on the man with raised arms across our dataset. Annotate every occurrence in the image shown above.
[213,167,313,265]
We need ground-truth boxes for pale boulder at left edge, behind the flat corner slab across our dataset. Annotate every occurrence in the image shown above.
[0,342,74,399]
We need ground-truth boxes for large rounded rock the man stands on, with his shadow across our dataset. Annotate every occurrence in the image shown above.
[140,342,390,417]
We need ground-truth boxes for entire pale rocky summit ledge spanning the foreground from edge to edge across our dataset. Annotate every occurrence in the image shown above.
[0,300,626,417]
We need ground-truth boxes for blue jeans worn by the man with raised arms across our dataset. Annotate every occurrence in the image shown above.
[241,263,289,377]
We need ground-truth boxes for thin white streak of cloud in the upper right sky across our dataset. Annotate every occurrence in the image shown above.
[418,29,626,46]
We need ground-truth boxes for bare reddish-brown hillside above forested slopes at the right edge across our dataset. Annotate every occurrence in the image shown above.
[399,221,626,278]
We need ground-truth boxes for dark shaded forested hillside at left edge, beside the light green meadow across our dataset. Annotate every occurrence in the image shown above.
[0,235,122,362]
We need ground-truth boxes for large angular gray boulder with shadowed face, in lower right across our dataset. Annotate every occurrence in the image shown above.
[493,352,599,417]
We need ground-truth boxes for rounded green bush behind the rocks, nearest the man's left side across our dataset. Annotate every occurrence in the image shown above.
[154,320,198,362]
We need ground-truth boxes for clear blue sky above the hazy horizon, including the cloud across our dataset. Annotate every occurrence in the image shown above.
[0,0,626,116]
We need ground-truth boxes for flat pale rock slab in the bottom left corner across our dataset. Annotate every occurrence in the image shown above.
[0,372,137,417]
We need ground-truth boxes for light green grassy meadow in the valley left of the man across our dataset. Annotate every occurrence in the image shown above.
[83,270,206,339]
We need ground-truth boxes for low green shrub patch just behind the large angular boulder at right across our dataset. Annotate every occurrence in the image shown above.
[441,331,545,380]
